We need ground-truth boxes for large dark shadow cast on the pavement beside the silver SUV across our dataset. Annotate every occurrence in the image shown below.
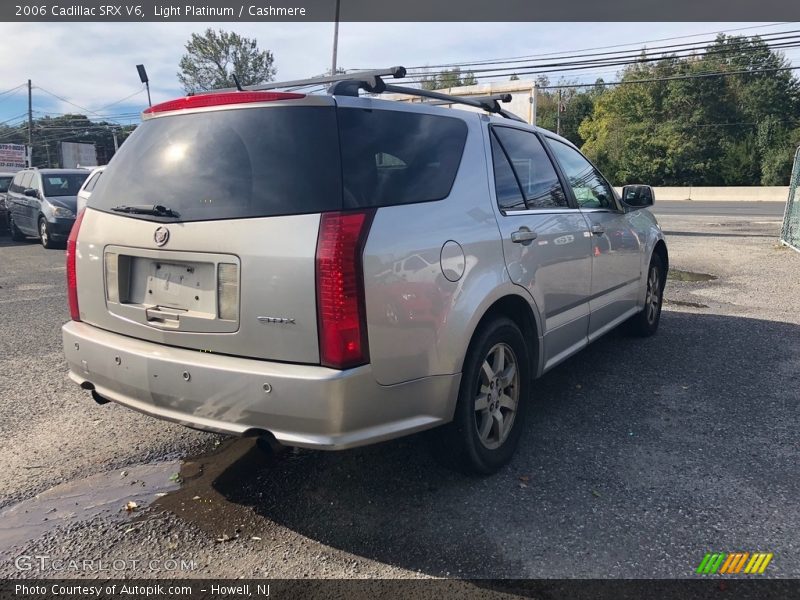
[209,311,800,578]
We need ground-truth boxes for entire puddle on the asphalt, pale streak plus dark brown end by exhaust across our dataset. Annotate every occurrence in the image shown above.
[0,438,272,553]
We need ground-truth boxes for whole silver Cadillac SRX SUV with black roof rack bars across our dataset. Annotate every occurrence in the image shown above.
[63,71,668,473]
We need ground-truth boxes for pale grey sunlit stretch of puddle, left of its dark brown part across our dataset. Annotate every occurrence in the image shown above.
[0,461,181,552]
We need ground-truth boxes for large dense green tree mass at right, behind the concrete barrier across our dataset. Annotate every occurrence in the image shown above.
[573,36,800,185]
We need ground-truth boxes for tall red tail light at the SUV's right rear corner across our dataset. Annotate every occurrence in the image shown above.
[317,211,374,369]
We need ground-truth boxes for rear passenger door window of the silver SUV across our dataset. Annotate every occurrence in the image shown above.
[492,127,569,210]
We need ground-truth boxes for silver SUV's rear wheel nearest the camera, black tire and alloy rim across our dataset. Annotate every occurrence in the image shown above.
[432,317,530,475]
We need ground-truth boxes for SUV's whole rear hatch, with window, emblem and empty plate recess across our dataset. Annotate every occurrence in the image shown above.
[76,93,342,363]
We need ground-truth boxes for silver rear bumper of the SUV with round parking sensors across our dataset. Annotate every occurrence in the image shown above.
[62,322,461,449]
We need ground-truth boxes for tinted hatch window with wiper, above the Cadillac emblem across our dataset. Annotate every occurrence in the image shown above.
[88,106,342,221]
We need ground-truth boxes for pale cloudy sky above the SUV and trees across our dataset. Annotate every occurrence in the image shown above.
[0,22,800,123]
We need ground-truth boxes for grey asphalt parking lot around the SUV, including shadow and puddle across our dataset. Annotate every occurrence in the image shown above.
[0,204,800,578]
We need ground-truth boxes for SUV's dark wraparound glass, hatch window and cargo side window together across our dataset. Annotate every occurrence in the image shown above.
[88,106,467,221]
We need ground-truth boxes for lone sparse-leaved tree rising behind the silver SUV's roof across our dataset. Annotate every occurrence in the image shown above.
[178,28,277,93]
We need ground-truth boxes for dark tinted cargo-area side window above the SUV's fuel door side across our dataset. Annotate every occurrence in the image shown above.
[338,108,467,208]
